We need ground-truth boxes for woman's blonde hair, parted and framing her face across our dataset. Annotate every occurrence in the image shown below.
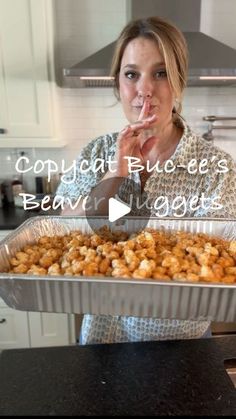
[110,17,188,113]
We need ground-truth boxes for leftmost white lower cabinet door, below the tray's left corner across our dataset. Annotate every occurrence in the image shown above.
[0,306,30,350]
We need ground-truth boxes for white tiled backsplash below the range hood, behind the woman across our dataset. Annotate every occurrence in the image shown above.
[0,87,236,193]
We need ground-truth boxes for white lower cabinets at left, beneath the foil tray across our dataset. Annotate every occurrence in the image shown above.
[0,230,76,350]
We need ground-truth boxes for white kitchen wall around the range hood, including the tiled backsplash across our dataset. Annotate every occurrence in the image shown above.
[0,0,236,192]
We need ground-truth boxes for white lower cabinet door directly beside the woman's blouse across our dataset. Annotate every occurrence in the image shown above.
[29,312,75,347]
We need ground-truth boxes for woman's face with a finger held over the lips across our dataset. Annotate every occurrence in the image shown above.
[119,37,174,127]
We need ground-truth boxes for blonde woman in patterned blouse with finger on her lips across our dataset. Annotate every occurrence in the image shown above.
[57,17,236,344]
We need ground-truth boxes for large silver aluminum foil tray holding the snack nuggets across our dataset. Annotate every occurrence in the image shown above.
[0,216,236,322]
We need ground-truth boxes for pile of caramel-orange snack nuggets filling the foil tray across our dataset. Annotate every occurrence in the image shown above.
[9,227,236,284]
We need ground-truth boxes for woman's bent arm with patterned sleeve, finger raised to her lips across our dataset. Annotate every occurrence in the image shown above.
[58,102,157,216]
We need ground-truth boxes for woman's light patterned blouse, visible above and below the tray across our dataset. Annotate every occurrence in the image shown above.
[57,119,236,344]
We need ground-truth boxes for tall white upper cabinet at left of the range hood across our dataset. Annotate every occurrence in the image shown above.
[0,0,64,147]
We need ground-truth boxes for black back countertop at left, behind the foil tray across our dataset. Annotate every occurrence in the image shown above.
[0,205,60,230]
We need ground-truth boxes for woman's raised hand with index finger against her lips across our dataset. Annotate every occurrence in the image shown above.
[115,100,157,177]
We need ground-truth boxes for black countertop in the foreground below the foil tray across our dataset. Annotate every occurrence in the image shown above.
[0,336,236,416]
